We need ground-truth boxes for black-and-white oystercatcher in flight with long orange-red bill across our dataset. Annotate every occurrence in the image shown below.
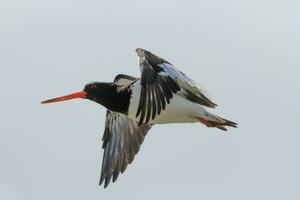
[41,48,238,188]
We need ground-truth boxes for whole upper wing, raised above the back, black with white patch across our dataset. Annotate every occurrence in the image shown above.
[136,48,216,125]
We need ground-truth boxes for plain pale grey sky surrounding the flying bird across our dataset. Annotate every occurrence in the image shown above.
[0,0,300,200]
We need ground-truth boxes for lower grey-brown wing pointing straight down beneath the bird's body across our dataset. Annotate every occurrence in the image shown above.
[99,110,151,188]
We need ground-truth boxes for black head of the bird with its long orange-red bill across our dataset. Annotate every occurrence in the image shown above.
[41,82,112,104]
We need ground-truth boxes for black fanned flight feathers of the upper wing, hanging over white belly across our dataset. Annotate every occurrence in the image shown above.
[136,49,180,125]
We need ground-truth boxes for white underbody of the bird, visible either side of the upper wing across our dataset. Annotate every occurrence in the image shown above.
[128,83,206,124]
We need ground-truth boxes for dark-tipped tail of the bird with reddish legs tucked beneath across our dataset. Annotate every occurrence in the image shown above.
[196,112,238,131]
